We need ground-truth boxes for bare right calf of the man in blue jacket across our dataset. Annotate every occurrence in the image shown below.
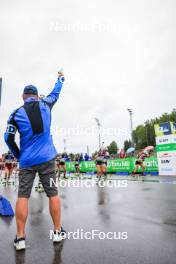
[49,196,61,230]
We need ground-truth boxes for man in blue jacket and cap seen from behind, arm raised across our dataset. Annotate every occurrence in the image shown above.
[4,72,64,250]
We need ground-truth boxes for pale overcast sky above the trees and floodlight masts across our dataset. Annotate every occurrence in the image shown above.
[0,0,176,152]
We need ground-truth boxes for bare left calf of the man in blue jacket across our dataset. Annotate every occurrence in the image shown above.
[16,198,28,238]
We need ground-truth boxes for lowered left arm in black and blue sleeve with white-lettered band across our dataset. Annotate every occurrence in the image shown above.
[4,111,20,159]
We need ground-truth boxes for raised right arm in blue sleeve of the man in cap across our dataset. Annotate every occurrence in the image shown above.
[42,73,64,108]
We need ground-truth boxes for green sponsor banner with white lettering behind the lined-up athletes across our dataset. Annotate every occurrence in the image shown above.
[66,157,158,173]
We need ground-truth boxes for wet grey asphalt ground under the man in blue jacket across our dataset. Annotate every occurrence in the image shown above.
[0,177,176,264]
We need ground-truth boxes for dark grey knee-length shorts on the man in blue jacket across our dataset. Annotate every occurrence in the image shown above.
[18,159,58,198]
